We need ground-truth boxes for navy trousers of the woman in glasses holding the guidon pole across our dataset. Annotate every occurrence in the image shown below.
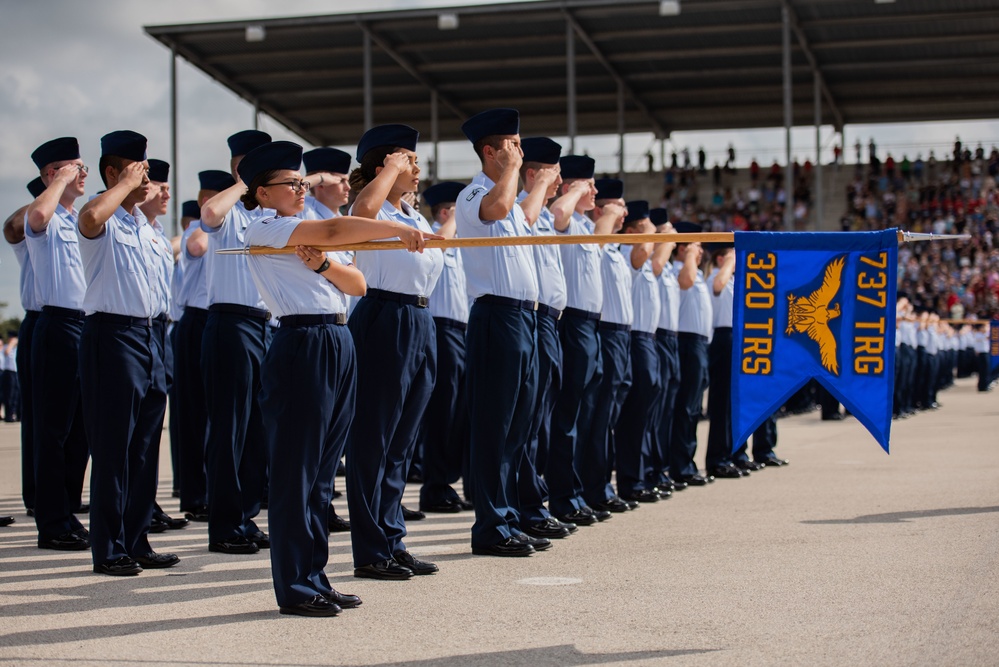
[260,324,357,607]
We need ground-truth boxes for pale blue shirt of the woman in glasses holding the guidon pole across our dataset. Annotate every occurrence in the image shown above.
[246,217,347,317]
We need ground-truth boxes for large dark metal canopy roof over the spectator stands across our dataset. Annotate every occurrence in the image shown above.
[145,0,999,145]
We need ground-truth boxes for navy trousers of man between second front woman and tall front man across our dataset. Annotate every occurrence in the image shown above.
[420,318,468,505]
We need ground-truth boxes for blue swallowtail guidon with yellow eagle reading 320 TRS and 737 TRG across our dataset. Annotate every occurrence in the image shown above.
[732,229,898,452]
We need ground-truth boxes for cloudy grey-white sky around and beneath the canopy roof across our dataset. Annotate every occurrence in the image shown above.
[0,0,999,318]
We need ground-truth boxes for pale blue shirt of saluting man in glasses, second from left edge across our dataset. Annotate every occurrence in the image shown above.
[24,204,87,310]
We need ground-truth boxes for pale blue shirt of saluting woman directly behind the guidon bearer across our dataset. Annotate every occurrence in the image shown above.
[354,197,444,296]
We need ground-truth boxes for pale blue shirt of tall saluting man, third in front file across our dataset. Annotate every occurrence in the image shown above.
[455,171,538,301]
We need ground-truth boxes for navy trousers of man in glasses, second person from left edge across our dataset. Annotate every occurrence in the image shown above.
[31,310,88,539]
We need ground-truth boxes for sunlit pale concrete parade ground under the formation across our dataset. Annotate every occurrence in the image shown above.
[0,380,999,667]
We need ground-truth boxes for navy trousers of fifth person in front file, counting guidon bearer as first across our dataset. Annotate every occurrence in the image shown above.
[544,311,600,516]
